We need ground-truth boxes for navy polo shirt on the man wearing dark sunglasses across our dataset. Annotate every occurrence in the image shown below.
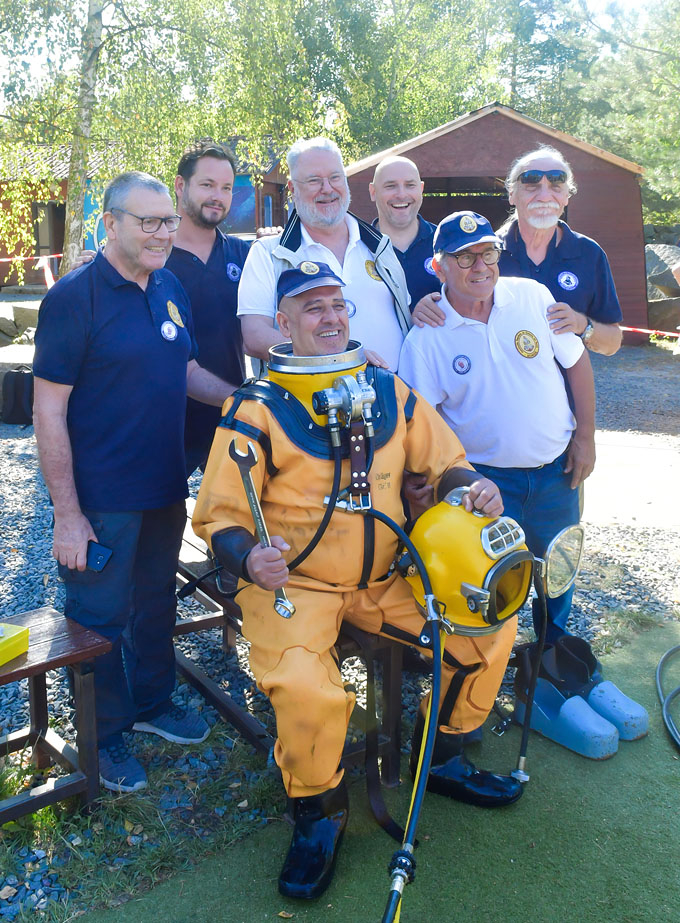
[499,220,622,324]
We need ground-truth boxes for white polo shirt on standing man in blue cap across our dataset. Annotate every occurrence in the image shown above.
[399,278,584,468]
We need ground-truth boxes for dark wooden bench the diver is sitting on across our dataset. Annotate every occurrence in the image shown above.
[175,500,403,786]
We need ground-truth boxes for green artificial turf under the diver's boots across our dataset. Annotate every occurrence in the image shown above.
[80,623,680,923]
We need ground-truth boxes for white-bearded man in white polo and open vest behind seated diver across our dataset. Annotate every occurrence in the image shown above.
[238,137,411,372]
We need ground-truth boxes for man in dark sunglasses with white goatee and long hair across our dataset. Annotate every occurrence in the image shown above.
[413,145,622,356]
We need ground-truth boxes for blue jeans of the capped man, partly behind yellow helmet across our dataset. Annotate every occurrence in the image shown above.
[474,452,580,641]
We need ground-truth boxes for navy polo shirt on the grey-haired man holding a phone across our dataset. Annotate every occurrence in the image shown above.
[33,253,195,512]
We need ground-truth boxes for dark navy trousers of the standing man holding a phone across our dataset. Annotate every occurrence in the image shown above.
[59,501,186,747]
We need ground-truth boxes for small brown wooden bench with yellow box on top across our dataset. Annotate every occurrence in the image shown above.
[0,606,111,825]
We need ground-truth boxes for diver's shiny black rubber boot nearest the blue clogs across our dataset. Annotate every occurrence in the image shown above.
[409,712,522,808]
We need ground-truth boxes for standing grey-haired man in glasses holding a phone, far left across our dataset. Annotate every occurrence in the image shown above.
[33,172,234,792]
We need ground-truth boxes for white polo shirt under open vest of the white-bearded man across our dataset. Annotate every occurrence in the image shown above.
[238,215,404,372]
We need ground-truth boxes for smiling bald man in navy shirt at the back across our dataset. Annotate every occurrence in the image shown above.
[368,156,440,310]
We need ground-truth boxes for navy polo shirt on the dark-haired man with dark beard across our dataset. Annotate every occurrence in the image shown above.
[166,229,250,462]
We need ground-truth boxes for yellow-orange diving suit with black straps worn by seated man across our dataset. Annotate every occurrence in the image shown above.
[193,347,517,798]
